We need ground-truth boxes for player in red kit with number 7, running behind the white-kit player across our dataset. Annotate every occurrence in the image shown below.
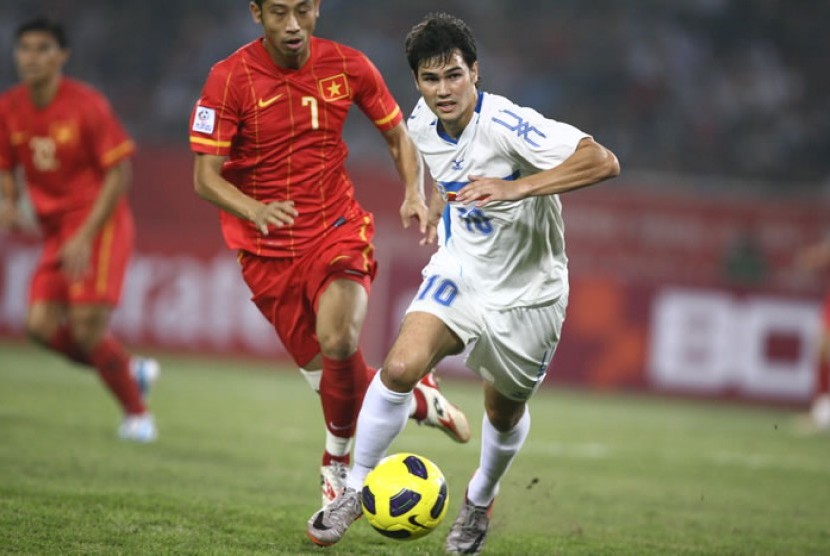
[190,0,470,502]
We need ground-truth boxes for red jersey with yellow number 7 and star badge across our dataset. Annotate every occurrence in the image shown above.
[190,37,402,257]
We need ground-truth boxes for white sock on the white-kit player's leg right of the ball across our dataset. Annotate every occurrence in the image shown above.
[467,407,530,507]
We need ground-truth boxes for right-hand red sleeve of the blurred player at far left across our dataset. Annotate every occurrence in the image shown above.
[85,92,135,169]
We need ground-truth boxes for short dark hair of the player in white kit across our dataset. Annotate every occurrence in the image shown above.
[405,13,478,75]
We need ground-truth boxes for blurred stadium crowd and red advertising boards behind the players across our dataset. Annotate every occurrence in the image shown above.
[0,0,830,402]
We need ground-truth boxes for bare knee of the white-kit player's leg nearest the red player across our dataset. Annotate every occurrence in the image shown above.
[381,311,464,391]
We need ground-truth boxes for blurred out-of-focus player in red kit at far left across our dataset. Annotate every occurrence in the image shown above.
[0,19,159,442]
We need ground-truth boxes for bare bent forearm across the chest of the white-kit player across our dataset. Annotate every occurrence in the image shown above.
[518,139,620,196]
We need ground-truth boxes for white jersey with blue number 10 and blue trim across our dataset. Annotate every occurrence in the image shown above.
[408,93,589,309]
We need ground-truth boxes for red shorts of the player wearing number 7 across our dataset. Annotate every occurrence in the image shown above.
[239,214,377,367]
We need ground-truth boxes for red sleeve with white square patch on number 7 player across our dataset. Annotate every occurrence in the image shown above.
[190,63,240,156]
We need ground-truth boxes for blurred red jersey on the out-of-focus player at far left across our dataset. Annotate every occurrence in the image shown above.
[0,77,135,233]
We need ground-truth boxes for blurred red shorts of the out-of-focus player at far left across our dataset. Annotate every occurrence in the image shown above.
[29,207,135,306]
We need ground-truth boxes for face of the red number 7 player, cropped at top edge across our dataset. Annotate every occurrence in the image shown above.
[250,0,320,68]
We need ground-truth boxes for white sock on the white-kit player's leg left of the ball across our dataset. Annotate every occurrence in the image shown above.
[346,371,412,490]
